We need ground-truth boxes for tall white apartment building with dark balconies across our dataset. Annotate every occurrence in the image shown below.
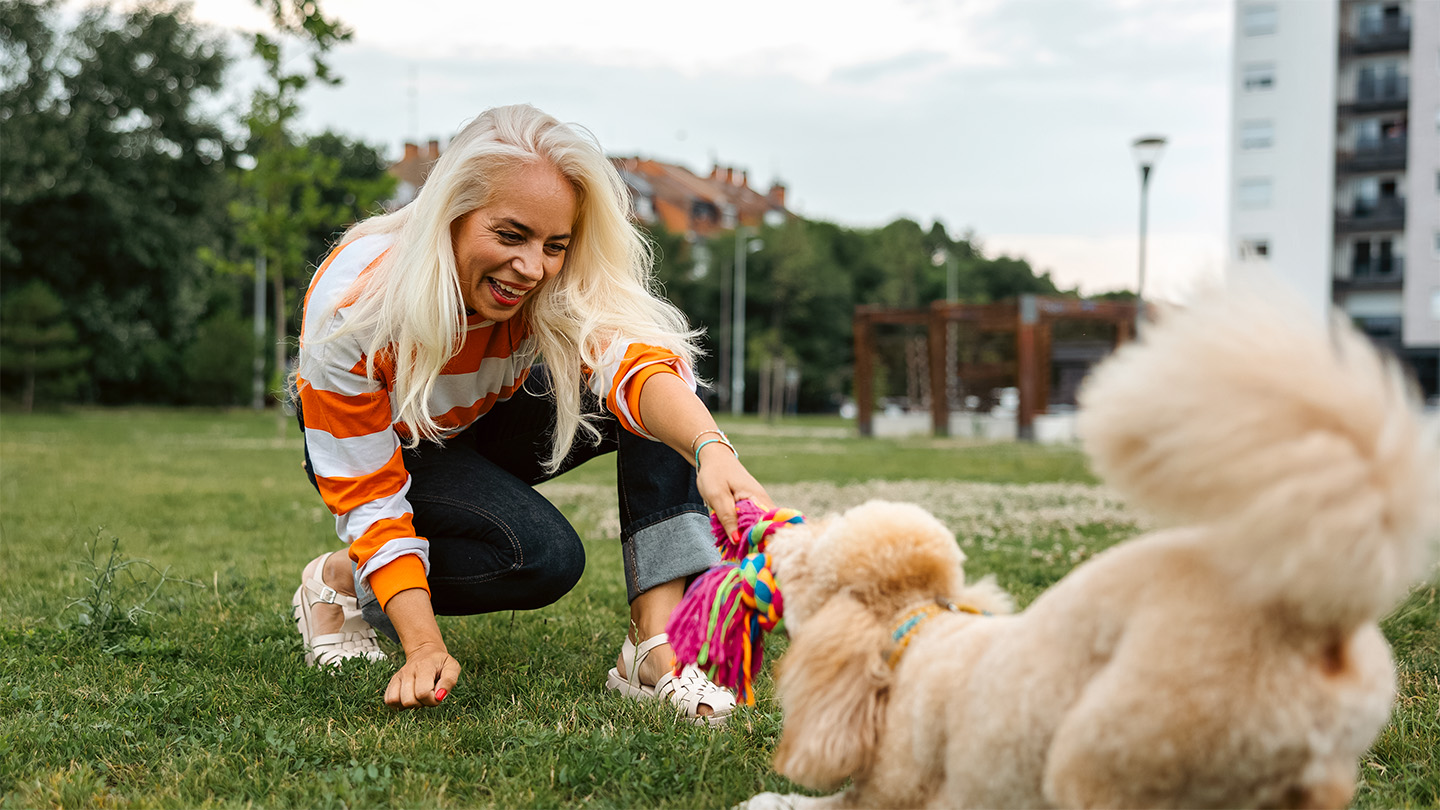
[1227,0,1440,399]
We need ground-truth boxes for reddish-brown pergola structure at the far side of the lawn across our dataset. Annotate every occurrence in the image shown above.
[854,295,1138,441]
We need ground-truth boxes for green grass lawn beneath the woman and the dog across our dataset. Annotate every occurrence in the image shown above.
[0,409,1440,807]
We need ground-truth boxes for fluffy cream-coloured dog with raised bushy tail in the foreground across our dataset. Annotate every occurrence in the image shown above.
[749,291,1440,807]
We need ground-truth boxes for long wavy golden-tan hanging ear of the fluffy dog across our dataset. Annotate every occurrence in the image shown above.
[775,594,890,790]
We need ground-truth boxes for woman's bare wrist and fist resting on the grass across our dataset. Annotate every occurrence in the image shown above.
[384,588,459,709]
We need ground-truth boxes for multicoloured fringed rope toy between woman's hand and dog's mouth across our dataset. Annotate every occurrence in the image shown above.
[665,500,805,706]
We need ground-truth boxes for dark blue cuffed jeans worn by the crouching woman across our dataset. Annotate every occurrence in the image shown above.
[301,366,720,638]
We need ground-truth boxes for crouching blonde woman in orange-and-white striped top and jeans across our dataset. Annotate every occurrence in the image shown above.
[285,105,769,722]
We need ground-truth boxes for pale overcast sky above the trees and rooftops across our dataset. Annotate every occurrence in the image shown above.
[174,0,1233,298]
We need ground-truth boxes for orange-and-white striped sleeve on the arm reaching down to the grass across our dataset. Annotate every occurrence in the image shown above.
[297,239,429,608]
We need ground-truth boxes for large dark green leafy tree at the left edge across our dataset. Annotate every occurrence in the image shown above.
[0,0,230,402]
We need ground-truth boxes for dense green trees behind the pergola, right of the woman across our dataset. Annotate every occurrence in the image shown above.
[649,218,1073,412]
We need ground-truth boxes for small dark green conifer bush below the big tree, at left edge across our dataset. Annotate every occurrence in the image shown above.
[0,280,89,411]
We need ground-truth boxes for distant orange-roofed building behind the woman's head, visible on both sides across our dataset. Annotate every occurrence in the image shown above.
[384,140,792,236]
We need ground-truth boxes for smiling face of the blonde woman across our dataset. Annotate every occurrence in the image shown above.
[451,161,576,321]
